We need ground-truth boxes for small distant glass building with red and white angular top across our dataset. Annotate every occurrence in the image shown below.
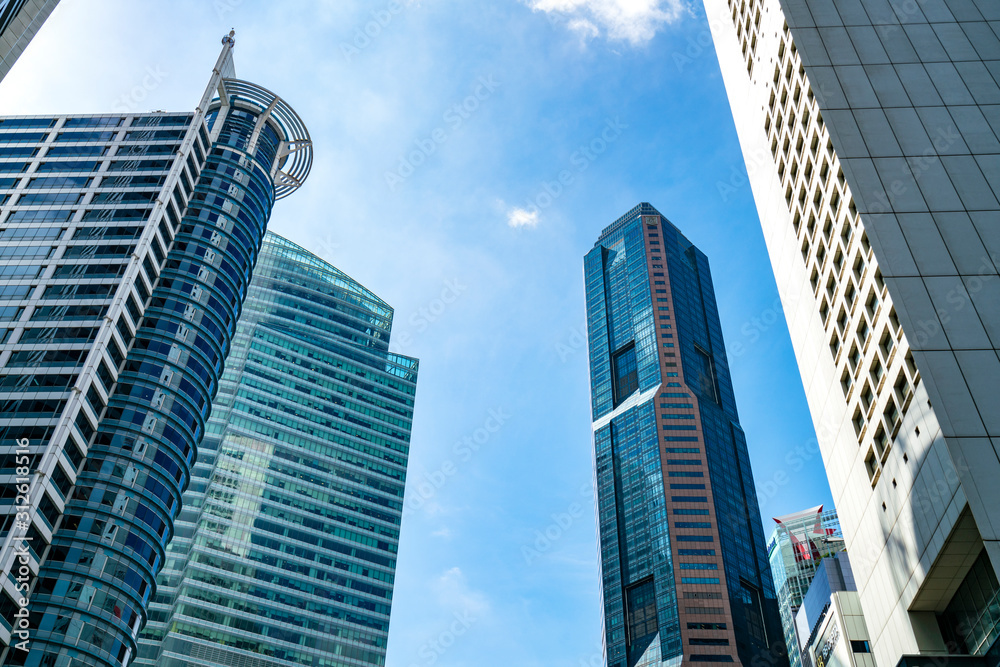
[767,505,844,667]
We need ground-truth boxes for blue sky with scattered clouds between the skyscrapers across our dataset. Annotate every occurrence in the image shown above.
[0,0,832,667]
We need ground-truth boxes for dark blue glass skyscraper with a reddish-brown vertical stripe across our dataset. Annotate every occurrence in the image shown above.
[584,203,787,667]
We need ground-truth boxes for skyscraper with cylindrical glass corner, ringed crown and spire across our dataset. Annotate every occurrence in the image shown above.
[0,34,312,667]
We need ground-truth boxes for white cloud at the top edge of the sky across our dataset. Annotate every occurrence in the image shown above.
[527,0,689,46]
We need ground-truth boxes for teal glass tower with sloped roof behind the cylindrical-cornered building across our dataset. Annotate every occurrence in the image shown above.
[135,233,417,667]
